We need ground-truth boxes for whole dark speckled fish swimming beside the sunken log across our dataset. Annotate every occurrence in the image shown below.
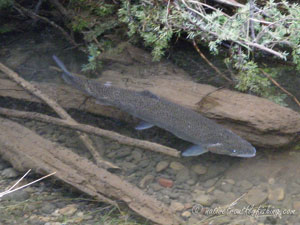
[53,55,256,158]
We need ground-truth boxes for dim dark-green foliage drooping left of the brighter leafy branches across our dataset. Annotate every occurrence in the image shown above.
[69,0,119,71]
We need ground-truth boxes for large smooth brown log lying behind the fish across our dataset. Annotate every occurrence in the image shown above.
[0,73,300,148]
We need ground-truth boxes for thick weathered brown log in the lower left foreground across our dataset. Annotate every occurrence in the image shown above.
[0,118,183,225]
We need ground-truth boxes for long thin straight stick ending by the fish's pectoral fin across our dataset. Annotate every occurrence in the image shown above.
[0,107,180,157]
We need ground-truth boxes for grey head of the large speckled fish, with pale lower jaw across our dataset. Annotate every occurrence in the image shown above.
[206,133,256,158]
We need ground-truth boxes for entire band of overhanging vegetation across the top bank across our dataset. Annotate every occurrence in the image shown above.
[0,0,300,103]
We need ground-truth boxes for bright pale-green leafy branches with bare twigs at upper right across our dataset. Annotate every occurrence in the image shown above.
[119,0,300,103]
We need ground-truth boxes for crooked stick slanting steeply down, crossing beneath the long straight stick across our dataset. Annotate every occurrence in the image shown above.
[0,63,118,169]
